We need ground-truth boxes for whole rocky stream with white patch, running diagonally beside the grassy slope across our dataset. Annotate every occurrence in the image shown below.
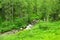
[0,20,39,35]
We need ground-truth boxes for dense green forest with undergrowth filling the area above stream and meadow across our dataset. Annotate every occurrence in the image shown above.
[0,0,60,32]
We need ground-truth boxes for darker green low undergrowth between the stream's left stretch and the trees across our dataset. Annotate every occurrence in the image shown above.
[0,19,28,33]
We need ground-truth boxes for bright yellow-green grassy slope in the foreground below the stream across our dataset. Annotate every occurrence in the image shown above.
[0,21,60,40]
